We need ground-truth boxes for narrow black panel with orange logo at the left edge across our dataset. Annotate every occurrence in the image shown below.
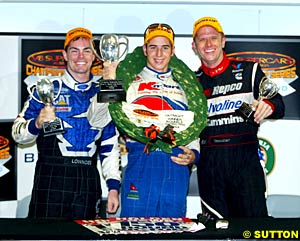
[0,122,17,201]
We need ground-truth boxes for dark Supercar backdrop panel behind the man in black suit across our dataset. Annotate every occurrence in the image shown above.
[225,37,300,120]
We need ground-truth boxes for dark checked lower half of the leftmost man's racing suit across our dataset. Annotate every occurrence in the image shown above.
[28,163,101,219]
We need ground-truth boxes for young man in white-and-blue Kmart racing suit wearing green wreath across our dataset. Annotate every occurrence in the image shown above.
[111,23,206,217]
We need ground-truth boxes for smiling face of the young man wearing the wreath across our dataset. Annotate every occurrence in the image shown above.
[143,36,175,73]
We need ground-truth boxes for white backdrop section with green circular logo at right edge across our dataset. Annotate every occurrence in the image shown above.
[258,120,300,195]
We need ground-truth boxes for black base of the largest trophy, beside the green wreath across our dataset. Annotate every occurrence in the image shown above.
[97,79,126,103]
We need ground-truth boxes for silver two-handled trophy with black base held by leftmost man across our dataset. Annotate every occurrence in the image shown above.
[27,76,65,136]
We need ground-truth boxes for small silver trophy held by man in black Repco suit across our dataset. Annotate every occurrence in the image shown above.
[235,77,279,126]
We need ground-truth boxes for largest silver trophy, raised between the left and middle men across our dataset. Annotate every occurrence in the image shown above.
[91,34,128,102]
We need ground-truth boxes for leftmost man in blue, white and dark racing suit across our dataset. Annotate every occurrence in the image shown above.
[12,27,120,219]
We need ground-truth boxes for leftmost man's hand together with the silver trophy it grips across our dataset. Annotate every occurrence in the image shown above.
[27,76,65,137]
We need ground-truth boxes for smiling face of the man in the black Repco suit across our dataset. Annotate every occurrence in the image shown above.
[192,26,226,68]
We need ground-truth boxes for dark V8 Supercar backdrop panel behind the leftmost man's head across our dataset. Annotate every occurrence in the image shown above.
[21,36,102,106]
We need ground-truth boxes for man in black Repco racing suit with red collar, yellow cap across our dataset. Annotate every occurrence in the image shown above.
[192,17,284,218]
